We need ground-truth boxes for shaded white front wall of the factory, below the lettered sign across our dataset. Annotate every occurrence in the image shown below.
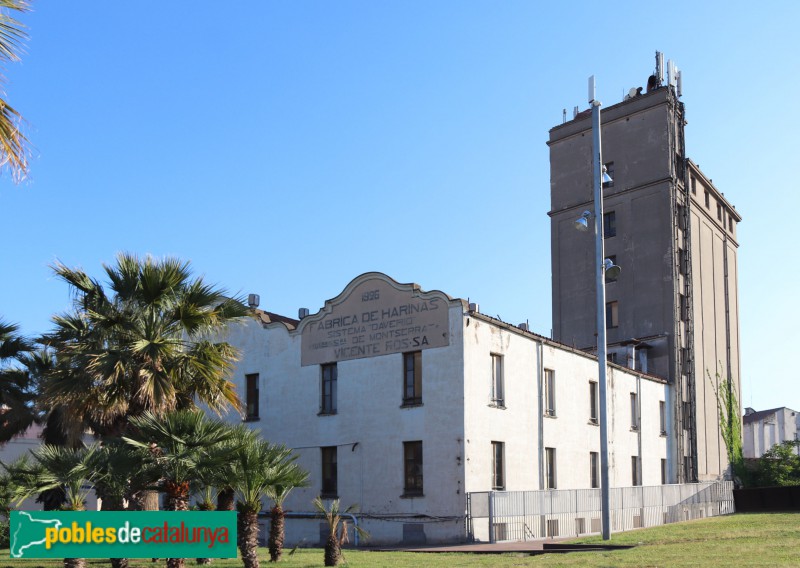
[219,278,465,543]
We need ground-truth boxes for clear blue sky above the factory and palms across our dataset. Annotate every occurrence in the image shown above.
[0,0,800,410]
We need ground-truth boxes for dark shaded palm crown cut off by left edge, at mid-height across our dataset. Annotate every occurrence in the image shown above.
[0,318,37,443]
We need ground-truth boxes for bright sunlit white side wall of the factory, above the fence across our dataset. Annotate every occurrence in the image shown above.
[464,317,667,491]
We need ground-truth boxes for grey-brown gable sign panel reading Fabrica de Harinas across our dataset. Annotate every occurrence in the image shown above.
[301,279,450,366]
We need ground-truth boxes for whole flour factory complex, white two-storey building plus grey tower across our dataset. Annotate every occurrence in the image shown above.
[219,57,742,543]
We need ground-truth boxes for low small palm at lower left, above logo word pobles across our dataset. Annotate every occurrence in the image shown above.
[16,444,98,568]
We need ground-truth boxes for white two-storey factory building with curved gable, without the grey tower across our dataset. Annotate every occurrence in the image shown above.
[222,272,671,544]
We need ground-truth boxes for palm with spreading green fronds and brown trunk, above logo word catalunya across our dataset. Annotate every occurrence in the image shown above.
[124,410,235,568]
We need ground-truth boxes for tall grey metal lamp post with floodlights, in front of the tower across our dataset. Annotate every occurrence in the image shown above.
[575,75,620,540]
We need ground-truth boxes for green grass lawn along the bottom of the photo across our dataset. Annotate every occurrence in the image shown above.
[0,513,800,568]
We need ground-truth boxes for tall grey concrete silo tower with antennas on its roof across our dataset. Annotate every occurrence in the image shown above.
[548,54,741,482]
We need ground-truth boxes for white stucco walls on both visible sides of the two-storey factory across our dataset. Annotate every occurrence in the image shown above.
[219,275,668,544]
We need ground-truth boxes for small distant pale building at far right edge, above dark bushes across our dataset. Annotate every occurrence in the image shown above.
[742,406,800,458]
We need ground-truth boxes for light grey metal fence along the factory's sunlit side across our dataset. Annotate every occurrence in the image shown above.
[467,481,734,542]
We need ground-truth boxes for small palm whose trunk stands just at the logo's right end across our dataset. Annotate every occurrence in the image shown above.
[234,439,308,568]
